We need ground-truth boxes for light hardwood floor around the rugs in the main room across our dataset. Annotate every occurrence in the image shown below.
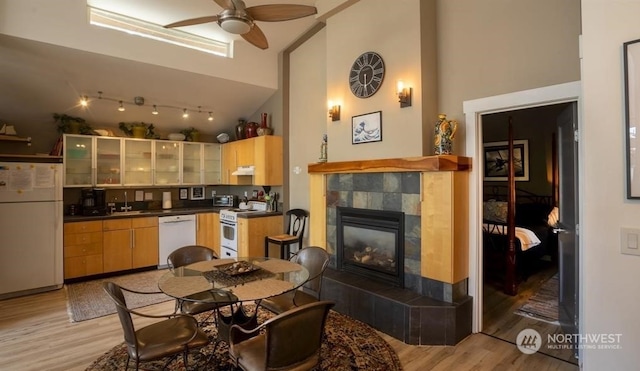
[0,289,577,371]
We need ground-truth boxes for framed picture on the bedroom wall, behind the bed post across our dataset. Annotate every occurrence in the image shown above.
[484,139,529,181]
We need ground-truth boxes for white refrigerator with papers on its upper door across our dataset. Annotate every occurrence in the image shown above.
[0,162,64,299]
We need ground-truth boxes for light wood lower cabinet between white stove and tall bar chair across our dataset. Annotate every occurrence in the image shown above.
[237,215,284,256]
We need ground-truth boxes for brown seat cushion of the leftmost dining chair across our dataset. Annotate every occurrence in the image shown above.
[130,317,209,361]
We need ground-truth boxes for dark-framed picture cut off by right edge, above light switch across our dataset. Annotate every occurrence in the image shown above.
[623,40,640,199]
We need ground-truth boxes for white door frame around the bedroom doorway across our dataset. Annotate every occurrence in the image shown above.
[462,81,582,333]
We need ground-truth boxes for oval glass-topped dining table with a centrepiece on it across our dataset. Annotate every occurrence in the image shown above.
[158,257,309,342]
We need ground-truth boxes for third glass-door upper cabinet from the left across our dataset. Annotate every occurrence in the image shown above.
[122,138,154,186]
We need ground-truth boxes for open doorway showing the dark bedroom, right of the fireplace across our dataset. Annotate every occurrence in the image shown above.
[481,102,577,364]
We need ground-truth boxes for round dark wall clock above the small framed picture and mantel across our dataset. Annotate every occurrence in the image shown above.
[349,52,384,98]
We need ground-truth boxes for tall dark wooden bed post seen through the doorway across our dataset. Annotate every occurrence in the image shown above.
[504,116,518,295]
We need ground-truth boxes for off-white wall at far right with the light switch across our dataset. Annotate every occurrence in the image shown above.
[580,0,640,370]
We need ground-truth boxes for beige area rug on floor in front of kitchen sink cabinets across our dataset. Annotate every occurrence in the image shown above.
[64,270,173,322]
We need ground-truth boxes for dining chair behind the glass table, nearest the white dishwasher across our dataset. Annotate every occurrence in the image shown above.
[167,245,218,321]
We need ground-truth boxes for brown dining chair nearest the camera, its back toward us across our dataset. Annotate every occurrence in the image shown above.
[229,301,335,370]
